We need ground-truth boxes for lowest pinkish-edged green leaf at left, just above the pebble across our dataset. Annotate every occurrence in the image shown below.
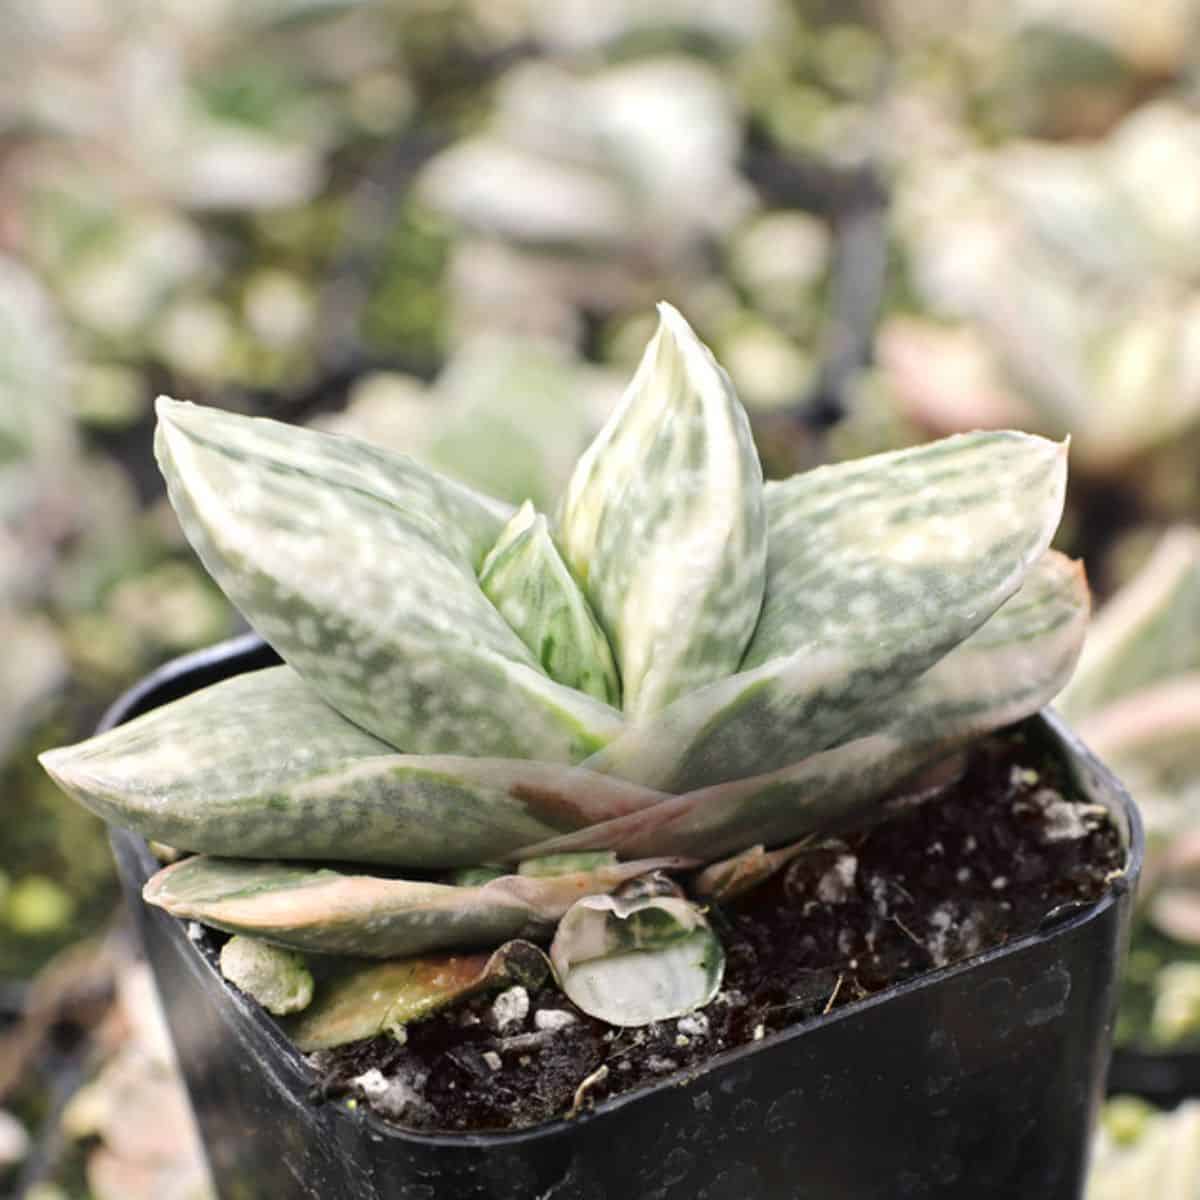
[142,856,690,959]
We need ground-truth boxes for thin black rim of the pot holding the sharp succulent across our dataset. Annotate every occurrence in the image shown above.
[97,632,1145,1147]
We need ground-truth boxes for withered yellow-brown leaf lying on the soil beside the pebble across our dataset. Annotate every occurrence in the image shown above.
[286,941,550,1054]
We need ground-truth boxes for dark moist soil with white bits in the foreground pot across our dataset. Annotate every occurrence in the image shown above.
[302,730,1123,1130]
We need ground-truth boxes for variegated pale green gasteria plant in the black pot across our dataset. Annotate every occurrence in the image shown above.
[42,305,1088,1045]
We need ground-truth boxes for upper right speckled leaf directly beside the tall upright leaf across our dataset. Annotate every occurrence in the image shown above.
[588,432,1067,792]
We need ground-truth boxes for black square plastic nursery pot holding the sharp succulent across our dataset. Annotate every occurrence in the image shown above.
[102,637,1142,1200]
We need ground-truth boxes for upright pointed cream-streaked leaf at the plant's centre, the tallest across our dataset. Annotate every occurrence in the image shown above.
[560,304,767,718]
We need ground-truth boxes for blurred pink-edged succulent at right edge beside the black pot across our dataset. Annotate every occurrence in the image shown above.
[1058,527,1200,1044]
